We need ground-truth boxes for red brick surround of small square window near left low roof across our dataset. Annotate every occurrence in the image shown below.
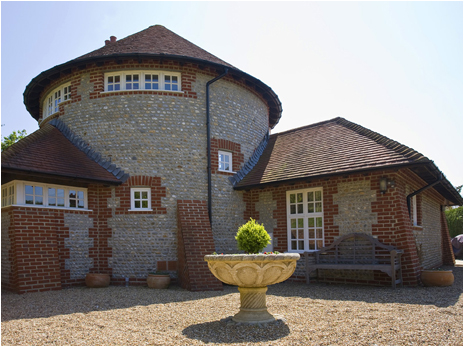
[115,176,166,214]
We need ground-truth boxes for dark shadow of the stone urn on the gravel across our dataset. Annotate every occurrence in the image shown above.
[182,317,290,345]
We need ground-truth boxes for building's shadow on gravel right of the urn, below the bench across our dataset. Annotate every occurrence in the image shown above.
[267,266,463,307]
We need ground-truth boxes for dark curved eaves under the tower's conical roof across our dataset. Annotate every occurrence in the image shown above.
[23,53,282,128]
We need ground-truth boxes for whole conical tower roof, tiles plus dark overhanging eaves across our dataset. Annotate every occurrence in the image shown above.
[23,25,282,128]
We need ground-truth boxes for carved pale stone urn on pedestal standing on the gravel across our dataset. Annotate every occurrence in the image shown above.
[204,253,300,324]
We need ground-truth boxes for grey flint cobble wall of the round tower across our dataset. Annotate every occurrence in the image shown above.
[44,66,268,277]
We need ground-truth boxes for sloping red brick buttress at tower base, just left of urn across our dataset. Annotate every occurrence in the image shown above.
[177,200,223,291]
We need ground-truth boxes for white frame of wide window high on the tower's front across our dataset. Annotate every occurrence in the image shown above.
[104,70,182,93]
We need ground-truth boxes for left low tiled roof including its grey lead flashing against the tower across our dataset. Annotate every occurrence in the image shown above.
[1,120,128,185]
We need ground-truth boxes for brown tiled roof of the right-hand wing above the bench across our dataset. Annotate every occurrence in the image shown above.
[233,117,462,205]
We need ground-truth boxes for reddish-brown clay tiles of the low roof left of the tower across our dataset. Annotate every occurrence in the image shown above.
[2,124,123,184]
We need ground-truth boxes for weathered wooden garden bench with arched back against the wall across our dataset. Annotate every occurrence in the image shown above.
[304,233,403,288]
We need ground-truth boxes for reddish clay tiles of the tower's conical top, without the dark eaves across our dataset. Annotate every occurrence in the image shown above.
[75,25,237,68]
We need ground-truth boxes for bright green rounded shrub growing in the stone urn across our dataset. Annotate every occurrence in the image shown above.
[235,218,271,254]
